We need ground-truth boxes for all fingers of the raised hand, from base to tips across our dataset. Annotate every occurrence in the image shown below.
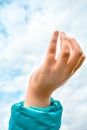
[46,31,85,75]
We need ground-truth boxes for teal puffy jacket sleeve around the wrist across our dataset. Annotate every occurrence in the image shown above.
[9,98,62,130]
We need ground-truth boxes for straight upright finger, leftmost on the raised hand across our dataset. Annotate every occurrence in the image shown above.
[46,31,59,63]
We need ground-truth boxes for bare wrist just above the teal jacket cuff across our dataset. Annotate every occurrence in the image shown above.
[24,86,50,108]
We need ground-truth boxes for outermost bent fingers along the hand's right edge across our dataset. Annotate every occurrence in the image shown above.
[62,36,85,74]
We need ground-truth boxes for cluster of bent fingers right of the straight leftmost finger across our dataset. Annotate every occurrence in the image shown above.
[57,32,85,75]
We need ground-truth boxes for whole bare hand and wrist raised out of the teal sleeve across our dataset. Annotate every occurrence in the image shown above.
[24,31,85,108]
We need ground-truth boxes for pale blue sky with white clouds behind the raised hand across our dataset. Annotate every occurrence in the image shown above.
[0,0,87,130]
